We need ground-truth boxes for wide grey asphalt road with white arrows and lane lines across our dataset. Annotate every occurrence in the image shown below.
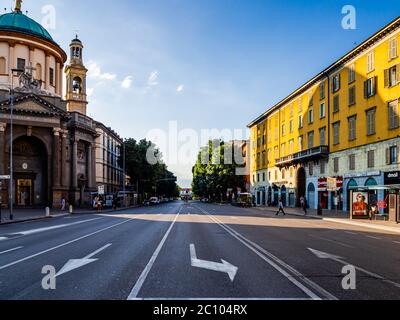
[0,202,400,300]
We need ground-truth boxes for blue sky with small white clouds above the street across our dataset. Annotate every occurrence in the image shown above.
[17,0,400,186]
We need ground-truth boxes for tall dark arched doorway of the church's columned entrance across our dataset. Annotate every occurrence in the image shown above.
[13,136,49,208]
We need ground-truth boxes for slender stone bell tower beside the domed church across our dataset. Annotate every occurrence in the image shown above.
[65,36,88,115]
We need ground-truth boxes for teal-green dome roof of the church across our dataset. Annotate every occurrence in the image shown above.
[0,11,54,42]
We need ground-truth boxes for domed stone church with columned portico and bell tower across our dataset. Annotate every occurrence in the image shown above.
[0,1,123,207]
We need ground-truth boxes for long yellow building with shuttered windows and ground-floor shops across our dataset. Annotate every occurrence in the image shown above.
[248,18,400,215]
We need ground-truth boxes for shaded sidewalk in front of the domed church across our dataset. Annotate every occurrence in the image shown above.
[0,206,138,225]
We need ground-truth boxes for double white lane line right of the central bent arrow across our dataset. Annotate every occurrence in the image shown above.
[195,208,338,300]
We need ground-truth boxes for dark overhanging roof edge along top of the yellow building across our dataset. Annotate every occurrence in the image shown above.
[247,16,400,128]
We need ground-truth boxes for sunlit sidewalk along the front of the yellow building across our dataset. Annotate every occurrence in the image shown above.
[256,207,400,234]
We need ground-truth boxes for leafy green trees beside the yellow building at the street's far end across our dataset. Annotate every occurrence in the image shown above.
[192,140,246,201]
